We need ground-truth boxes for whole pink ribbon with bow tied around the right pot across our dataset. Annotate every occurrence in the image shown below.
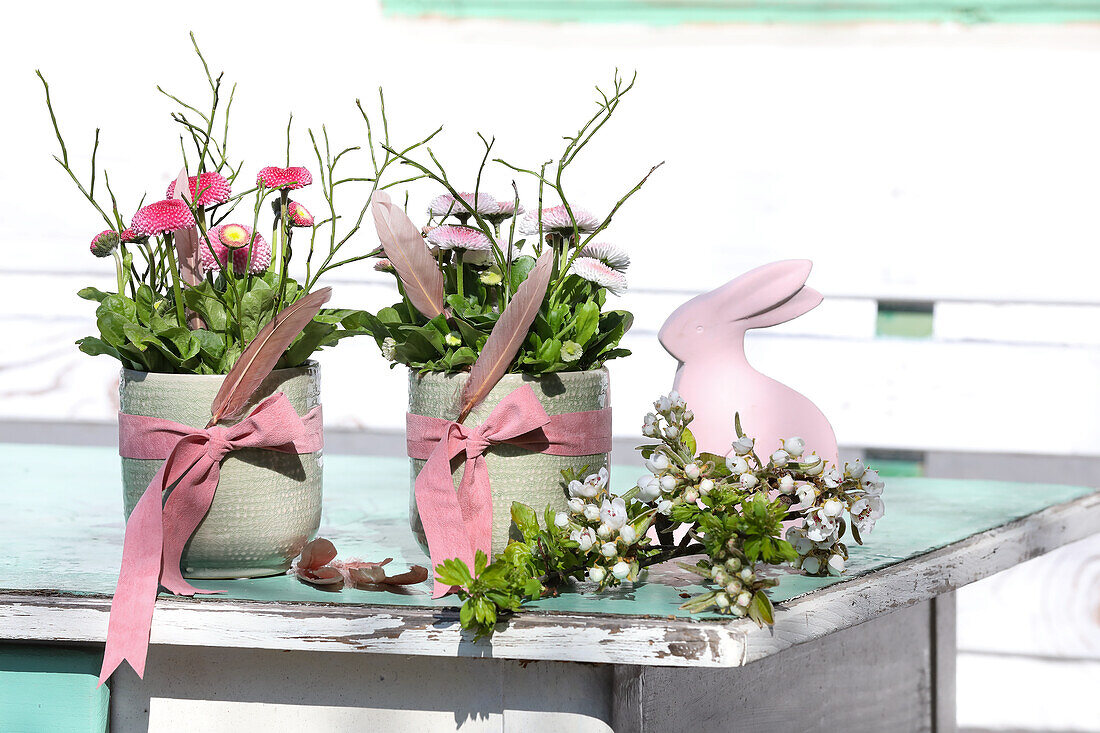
[406,384,612,598]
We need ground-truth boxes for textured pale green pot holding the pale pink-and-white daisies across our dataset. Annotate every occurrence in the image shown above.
[409,369,611,554]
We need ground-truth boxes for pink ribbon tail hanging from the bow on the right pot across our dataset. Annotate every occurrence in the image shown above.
[414,437,474,598]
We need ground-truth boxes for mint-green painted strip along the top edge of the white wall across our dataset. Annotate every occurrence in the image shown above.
[382,0,1100,25]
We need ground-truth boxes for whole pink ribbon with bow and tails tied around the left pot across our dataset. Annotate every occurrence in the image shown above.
[99,392,323,685]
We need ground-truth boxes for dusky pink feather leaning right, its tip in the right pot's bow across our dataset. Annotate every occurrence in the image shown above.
[459,249,553,422]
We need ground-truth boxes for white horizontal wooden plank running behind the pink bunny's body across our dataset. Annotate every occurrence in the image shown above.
[0,320,1100,456]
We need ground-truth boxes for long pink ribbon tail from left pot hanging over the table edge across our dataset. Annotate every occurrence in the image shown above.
[99,467,165,685]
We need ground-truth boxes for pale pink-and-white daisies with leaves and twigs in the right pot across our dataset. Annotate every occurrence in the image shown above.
[358,70,657,374]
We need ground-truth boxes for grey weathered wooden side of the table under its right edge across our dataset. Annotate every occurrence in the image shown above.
[612,593,956,733]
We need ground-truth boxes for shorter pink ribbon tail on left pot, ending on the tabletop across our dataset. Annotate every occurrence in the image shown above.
[161,456,224,595]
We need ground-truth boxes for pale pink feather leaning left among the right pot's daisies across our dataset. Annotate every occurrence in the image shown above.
[371,190,446,318]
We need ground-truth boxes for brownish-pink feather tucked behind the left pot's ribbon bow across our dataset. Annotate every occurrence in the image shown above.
[207,287,332,427]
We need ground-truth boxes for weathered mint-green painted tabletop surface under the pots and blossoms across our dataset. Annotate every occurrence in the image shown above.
[0,445,1097,616]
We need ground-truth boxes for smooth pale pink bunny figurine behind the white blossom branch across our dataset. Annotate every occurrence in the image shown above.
[658,260,837,466]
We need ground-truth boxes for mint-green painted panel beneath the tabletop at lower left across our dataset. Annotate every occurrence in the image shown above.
[0,644,110,733]
